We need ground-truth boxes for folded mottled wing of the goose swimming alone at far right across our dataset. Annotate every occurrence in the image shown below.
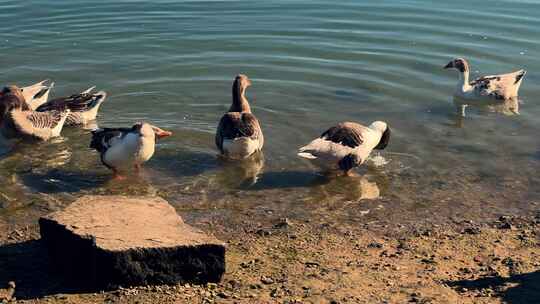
[470,70,526,100]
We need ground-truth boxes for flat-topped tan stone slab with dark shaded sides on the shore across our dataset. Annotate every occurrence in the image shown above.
[39,196,225,288]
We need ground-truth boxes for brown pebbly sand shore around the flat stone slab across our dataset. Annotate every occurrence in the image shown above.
[0,205,540,303]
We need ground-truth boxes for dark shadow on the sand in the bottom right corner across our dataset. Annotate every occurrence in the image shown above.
[447,271,540,304]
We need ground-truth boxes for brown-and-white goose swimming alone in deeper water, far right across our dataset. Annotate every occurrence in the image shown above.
[444,58,526,102]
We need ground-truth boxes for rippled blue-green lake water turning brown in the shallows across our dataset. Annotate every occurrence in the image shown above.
[0,0,540,228]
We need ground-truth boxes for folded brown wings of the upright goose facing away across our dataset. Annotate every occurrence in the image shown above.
[216,112,264,152]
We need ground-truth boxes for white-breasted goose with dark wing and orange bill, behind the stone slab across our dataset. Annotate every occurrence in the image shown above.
[90,122,172,180]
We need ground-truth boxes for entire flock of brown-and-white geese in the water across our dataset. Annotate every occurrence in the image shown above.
[0,58,525,179]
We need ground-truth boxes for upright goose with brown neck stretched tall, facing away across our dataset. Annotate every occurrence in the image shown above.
[215,74,264,159]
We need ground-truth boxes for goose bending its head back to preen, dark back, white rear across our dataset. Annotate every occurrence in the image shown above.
[298,121,390,176]
